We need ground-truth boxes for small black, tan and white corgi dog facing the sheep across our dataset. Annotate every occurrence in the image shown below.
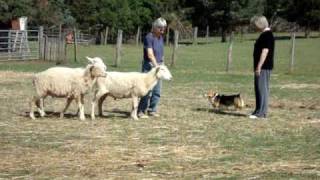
[205,90,244,110]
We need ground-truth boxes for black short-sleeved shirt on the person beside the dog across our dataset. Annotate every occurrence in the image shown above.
[253,31,274,70]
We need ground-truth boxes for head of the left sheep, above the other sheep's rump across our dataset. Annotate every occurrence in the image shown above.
[86,56,107,77]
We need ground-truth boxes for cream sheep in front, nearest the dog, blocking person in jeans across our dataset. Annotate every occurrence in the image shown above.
[91,65,172,120]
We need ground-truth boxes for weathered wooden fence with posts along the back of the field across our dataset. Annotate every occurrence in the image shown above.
[0,26,310,73]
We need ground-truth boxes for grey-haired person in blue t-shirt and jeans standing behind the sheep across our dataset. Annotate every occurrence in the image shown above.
[138,17,167,118]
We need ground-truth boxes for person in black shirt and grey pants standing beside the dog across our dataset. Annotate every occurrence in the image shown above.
[249,16,275,119]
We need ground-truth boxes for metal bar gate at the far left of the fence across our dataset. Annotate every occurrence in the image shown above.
[0,30,40,61]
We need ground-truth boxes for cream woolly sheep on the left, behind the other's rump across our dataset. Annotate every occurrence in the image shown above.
[29,57,107,120]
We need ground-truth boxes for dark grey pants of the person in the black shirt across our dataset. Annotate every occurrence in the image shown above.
[252,69,271,117]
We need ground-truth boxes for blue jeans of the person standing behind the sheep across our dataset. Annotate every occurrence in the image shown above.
[138,61,162,113]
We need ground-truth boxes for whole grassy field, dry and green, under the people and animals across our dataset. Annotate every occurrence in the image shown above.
[0,34,320,179]
